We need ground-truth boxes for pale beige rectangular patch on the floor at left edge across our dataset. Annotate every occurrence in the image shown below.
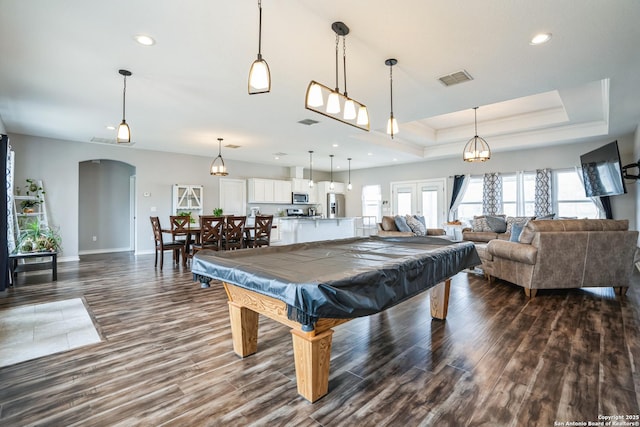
[0,298,101,367]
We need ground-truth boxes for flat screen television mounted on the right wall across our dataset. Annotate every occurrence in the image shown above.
[580,141,627,197]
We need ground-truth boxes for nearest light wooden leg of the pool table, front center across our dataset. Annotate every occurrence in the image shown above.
[291,329,333,403]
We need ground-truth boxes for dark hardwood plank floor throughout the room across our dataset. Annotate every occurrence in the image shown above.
[0,254,640,426]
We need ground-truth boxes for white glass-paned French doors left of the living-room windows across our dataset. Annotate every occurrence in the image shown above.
[391,179,447,228]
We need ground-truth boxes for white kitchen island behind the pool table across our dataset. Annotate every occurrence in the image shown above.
[278,216,356,245]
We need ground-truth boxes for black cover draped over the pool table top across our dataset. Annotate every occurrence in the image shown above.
[191,236,481,328]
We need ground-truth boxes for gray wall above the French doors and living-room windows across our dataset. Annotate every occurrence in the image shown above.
[334,135,640,229]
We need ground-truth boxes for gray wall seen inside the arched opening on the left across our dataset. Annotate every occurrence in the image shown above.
[78,159,135,254]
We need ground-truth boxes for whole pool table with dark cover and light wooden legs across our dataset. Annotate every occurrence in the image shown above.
[191,236,480,402]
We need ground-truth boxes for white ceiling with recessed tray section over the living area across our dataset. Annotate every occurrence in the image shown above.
[0,0,640,170]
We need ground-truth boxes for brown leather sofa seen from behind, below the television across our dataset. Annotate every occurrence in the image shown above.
[482,219,638,298]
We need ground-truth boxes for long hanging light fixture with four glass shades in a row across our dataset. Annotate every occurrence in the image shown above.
[305,22,369,131]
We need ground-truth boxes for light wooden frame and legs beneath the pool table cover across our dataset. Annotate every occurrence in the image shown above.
[223,279,451,402]
